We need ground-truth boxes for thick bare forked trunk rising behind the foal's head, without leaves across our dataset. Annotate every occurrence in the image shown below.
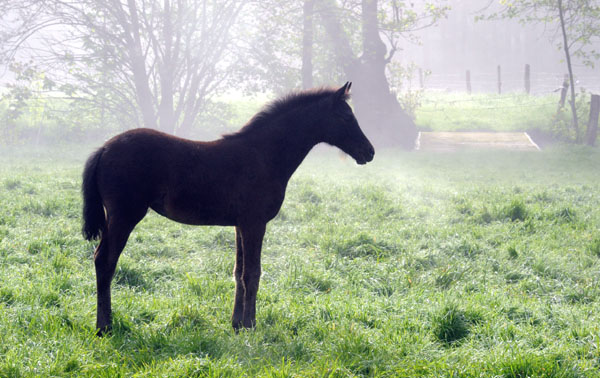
[320,0,417,149]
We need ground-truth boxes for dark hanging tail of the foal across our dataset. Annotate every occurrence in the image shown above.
[81,148,106,240]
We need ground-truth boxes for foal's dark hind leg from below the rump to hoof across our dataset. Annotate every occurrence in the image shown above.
[94,211,143,335]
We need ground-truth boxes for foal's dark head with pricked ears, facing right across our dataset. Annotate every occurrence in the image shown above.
[323,82,375,164]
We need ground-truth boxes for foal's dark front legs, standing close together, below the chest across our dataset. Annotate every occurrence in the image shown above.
[232,224,266,330]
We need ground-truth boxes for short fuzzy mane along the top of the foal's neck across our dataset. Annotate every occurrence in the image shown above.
[223,88,350,138]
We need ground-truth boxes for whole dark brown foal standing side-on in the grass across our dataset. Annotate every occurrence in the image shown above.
[83,83,375,334]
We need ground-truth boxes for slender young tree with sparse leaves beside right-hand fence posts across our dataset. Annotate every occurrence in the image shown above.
[486,0,600,143]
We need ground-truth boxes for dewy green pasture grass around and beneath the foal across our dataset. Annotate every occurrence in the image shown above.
[0,147,600,378]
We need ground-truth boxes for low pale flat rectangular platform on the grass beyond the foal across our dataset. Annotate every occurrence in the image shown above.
[415,131,540,151]
